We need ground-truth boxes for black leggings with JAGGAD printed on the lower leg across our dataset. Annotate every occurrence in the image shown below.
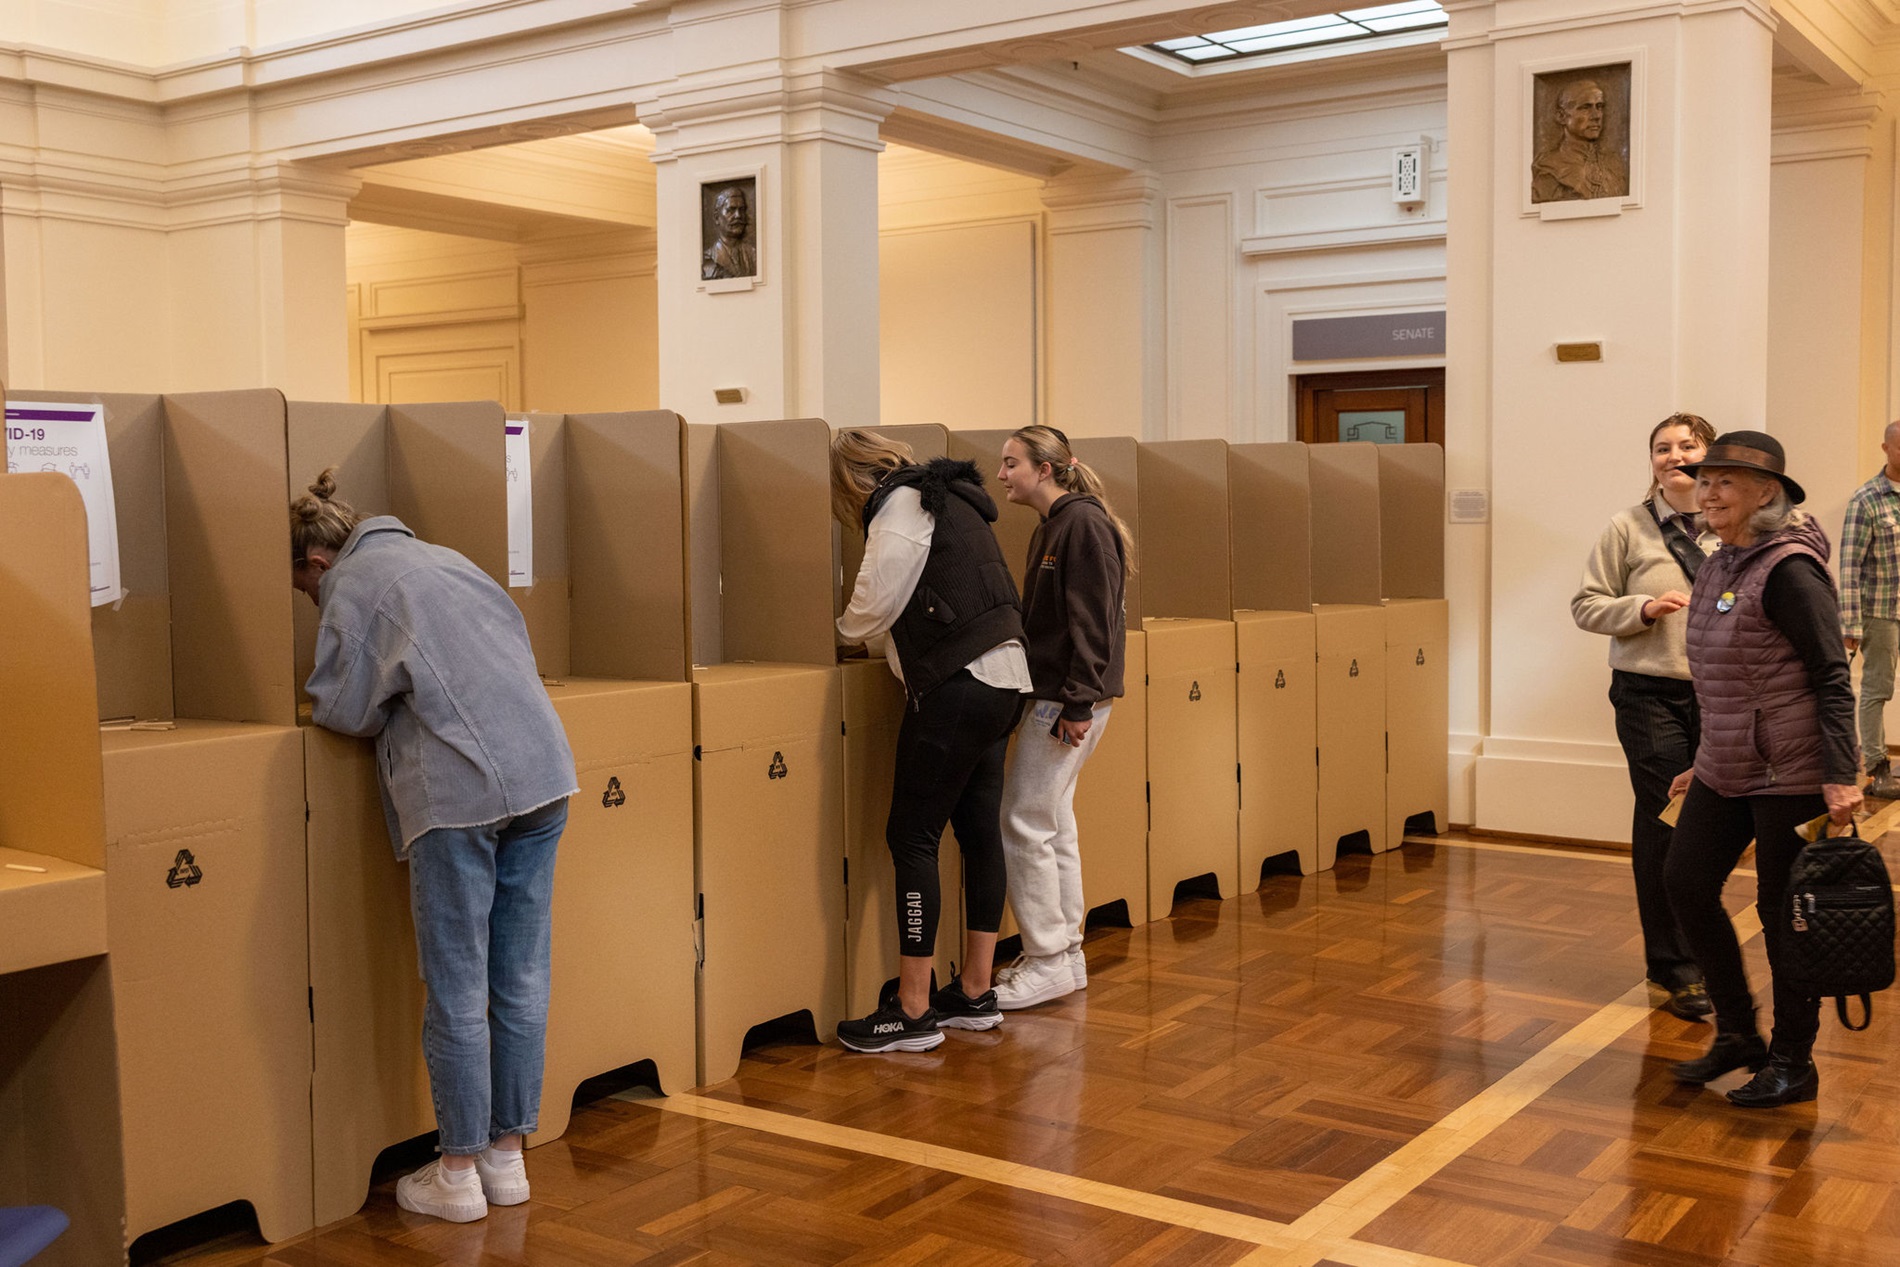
[884,669,1022,957]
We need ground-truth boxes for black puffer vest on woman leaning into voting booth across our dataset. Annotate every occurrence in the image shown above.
[863,458,1022,709]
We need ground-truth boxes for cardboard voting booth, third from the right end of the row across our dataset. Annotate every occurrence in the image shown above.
[1227,441,1319,887]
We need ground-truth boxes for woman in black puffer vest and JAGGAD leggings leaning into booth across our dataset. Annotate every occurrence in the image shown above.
[832,431,1030,1052]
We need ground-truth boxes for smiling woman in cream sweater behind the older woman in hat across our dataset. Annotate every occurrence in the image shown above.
[1569,414,1716,1020]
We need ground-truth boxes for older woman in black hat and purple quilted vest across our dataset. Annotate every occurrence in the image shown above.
[1664,431,1860,1109]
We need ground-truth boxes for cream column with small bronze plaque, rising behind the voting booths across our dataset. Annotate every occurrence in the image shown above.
[642,72,891,425]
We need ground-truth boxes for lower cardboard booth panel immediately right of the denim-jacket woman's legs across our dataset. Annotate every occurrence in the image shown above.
[528,680,697,1145]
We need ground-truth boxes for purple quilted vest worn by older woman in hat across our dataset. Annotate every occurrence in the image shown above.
[1689,515,1830,796]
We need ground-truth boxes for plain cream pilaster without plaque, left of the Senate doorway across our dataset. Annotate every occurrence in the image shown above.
[1041,173,1165,439]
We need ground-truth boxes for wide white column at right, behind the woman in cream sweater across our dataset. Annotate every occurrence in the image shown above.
[1446,0,1775,840]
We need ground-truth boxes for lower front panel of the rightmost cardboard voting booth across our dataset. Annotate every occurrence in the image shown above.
[1385,598,1452,847]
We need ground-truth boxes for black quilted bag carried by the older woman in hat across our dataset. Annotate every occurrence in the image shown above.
[1777,832,1894,1030]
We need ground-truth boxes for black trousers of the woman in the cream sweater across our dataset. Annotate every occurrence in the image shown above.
[1609,669,1702,990]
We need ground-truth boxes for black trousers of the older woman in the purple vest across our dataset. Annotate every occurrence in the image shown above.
[1666,783,1828,1060]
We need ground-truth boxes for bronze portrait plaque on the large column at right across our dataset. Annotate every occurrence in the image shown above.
[1531,61,1630,203]
